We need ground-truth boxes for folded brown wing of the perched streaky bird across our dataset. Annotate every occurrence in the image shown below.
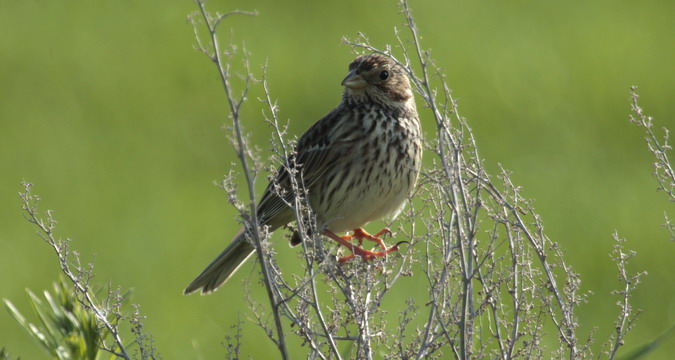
[258,107,348,226]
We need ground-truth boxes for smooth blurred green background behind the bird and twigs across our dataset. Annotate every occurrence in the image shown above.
[0,0,675,359]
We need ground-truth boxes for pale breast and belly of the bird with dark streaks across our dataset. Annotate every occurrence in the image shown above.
[310,108,421,232]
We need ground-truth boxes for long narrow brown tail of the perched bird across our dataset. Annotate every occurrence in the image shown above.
[183,231,255,295]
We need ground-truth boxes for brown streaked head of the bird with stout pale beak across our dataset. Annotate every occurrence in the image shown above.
[342,54,413,106]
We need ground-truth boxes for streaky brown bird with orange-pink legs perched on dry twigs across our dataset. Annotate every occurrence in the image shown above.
[184,53,422,295]
